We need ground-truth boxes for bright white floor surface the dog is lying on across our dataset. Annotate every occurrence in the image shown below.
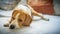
[0,15,60,34]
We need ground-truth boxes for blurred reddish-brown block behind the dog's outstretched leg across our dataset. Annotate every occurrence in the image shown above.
[29,0,54,15]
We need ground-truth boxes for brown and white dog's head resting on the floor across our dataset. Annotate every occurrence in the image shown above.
[9,10,32,29]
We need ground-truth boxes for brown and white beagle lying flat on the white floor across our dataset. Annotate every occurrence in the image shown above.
[4,5,49,29]
